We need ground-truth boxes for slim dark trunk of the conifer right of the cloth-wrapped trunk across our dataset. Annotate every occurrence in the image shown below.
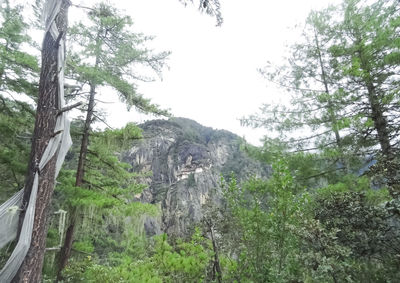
[56,84,96,282]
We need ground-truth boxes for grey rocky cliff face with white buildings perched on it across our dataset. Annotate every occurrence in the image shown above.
[123,118,268,236]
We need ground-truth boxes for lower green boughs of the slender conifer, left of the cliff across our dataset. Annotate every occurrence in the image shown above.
[56,124,148,209]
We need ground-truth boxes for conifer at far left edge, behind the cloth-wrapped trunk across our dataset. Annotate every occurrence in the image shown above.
[0,0,39,200]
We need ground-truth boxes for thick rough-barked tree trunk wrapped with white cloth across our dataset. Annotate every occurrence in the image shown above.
[13,0,70,283]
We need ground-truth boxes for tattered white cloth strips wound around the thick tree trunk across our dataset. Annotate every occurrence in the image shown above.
[0,0,72,283]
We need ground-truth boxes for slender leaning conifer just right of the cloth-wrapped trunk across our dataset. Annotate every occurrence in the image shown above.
[57,3,169,279]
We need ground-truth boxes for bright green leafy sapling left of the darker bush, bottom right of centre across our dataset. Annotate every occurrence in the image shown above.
[225,160,307,282]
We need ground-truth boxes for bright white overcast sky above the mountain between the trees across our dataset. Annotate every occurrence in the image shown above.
[70,0,338,144]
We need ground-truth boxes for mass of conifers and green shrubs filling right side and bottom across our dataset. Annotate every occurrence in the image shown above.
[49,0,400,282]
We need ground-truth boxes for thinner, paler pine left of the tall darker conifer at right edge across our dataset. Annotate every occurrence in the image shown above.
[242,7,357,185]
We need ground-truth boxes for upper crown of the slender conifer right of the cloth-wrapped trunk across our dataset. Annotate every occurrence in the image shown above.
[67,3,169,115]
